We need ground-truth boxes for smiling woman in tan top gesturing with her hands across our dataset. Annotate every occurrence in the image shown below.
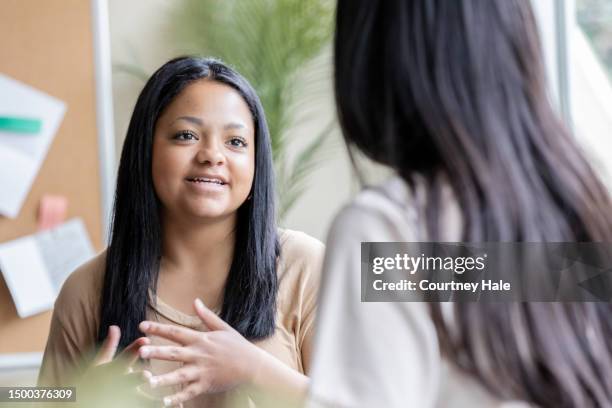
[40,57,323,407]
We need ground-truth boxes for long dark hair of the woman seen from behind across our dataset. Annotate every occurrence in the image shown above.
[334,0,612,407]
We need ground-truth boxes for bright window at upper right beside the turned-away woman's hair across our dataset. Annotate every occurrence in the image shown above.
[531,0,612,189]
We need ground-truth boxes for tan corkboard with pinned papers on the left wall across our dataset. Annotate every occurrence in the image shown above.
[0,0,102,353]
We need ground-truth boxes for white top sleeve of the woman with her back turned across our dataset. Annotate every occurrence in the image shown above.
[309,206,441,408]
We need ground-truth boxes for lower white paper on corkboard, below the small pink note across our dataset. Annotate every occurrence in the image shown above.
[0,218,94,318]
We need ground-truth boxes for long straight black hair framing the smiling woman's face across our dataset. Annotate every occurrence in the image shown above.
[98,57,280,348]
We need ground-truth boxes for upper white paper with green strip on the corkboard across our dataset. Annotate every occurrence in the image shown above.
[0,74,66,218]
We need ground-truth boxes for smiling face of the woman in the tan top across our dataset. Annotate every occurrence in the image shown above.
[152,79,255,220]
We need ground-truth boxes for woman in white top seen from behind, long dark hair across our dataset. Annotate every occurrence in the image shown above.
[311,0,612,408]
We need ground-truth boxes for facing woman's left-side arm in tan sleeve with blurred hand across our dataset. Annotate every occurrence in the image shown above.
[38,254,149,406]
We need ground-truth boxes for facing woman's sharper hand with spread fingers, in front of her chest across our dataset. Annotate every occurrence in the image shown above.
[139,299,264,406]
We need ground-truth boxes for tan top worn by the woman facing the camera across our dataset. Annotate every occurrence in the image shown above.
[39,230,324,408]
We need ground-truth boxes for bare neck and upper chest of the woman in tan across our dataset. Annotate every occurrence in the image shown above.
[157,215,236,314]
